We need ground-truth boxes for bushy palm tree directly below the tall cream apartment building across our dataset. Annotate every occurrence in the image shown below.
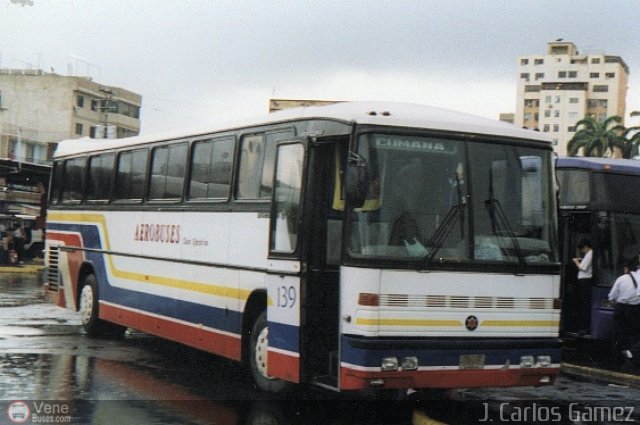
[567,115,624,157]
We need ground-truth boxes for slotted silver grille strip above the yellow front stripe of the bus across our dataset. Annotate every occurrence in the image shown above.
[380,294,553,310]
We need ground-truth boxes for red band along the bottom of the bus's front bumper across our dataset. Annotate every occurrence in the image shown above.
[340,367,560,390]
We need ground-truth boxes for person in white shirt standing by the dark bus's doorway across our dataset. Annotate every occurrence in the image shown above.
[573,239,593,334]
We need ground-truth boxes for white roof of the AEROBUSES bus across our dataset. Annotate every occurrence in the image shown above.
[55,102,551,157]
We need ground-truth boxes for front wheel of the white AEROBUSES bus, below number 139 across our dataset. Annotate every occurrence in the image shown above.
[249,311,293,393]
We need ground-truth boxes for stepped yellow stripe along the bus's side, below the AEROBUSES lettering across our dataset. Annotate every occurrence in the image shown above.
[49,213,256,305]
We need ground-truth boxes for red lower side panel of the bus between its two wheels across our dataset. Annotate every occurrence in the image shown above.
[100,303,242,360]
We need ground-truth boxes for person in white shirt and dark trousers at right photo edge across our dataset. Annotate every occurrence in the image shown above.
[609,259,640,364]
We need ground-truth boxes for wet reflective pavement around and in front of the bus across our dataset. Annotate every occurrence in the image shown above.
[0,271,640,424]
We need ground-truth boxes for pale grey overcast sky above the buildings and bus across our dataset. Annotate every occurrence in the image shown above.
[0,0,640,133]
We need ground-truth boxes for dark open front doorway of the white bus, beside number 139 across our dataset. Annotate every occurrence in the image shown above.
[302,138,348,389]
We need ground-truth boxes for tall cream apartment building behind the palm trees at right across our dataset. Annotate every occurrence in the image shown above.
[515,40,629,155]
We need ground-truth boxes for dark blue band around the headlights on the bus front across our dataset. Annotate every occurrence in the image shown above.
[340,335,561,367]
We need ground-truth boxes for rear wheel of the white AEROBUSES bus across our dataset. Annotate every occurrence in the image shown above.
[79,274,126,337]
